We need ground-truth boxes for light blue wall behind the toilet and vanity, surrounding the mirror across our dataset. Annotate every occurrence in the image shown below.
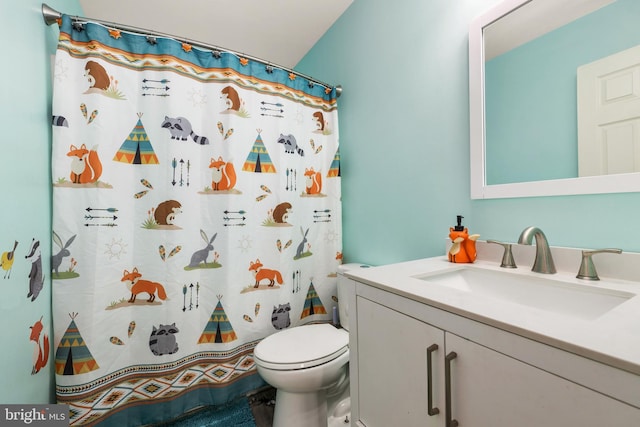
[296,0,640,268]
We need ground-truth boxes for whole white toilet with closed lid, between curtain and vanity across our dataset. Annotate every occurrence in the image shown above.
[254,264,367,427]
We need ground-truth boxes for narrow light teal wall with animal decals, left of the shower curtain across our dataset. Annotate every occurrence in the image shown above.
[0,0,81,403]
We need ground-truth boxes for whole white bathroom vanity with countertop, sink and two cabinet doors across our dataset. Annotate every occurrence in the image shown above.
[346,242,640,427]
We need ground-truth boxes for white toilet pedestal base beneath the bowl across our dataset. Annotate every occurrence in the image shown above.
[273,389,327,427]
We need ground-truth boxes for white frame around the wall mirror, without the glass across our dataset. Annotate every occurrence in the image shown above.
[469,0,640,199]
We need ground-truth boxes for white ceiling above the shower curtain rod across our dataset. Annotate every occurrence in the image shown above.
[79,0,353,68]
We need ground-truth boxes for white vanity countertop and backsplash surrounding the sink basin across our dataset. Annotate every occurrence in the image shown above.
[345,242,640,375]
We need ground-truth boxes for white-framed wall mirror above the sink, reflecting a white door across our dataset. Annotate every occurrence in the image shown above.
[469,0,640,199]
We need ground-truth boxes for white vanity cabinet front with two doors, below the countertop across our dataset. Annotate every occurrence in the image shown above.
[350,283,640,427]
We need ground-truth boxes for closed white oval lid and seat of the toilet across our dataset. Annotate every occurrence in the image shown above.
[253,323,349,370]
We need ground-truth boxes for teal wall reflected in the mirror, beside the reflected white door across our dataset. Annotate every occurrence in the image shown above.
[485,0,640,184]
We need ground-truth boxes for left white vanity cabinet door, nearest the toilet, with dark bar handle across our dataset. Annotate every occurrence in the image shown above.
[357,297,444,427]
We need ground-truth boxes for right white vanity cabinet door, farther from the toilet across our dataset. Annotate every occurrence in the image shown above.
[446,333,640,427]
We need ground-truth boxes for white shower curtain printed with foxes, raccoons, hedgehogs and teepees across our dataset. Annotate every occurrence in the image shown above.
[50,16,342,426]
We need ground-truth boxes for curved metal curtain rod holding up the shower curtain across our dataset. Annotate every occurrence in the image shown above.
[42,3,342,97]
